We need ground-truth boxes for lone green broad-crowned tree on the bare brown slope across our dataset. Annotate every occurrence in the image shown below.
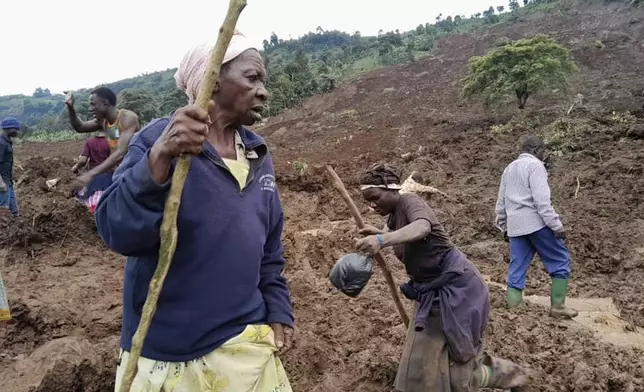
[463,35,578,109]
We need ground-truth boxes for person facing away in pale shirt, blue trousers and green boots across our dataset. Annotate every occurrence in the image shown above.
[496,136,577,318]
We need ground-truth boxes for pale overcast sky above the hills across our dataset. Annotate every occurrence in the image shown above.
[0,0,507,95]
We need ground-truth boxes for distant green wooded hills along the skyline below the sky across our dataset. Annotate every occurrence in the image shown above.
[0,0,644,142]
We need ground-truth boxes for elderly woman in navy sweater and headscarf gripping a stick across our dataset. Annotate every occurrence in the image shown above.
[96,33,294,392]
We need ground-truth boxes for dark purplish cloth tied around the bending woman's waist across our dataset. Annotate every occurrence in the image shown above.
[400,248,490,362]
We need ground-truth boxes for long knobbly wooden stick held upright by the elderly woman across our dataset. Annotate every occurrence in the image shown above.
[119,0,246,392]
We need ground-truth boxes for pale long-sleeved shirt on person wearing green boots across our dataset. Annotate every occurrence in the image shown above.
[496,153,563,237]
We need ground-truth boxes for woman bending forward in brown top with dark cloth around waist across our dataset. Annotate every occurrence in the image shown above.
[356,164,528,392]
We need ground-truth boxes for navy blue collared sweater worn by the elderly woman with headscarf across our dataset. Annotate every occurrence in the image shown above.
[95,118,293,362]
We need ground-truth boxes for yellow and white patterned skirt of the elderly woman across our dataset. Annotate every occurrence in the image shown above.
[115,325,293,392]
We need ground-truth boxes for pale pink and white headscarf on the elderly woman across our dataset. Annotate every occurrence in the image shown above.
[174,30,259,104]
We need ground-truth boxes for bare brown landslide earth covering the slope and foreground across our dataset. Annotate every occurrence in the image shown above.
[0,6,644,392]
